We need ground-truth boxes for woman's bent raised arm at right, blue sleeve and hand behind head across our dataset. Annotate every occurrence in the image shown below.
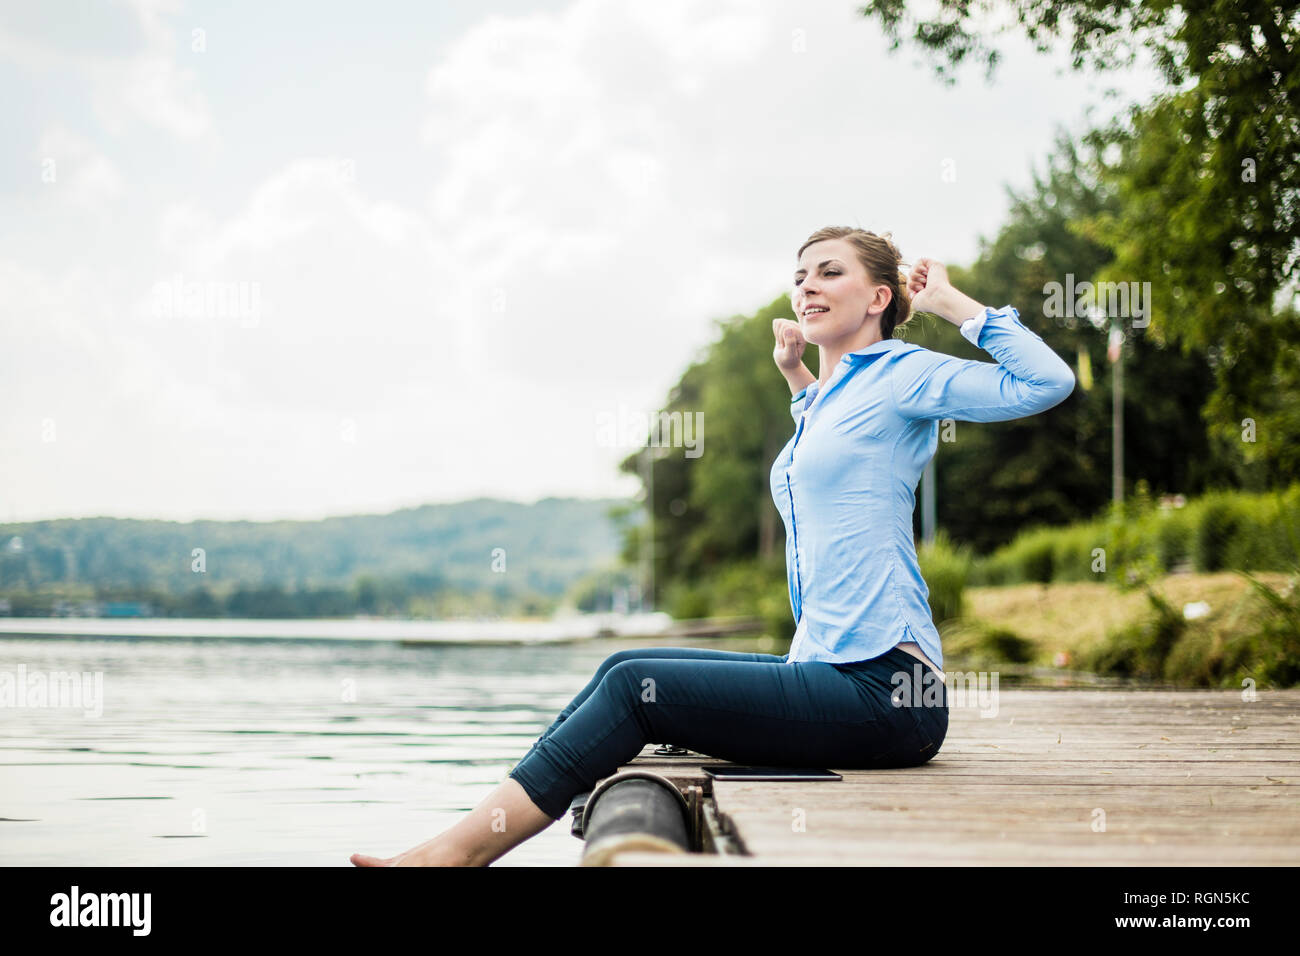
[891,259,1075,421]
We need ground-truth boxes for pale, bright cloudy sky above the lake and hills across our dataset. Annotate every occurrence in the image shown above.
[0,0,1158,522]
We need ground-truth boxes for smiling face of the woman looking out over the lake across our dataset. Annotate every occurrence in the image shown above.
[790,239,891,345]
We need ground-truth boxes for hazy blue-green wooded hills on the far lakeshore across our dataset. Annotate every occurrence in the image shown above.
[0,498,637,619]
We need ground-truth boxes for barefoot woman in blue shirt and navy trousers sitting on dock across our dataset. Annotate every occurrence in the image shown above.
[352,226,1074,866]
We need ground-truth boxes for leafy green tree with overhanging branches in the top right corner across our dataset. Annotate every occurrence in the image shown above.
[861,0,1300,486]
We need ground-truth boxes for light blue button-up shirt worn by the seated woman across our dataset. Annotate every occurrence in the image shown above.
[771,306,1074,670]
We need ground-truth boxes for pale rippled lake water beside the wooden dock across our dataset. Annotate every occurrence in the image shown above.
[0,637,706,866]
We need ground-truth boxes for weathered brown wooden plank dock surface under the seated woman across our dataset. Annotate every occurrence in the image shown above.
[595,688,1300,866]
